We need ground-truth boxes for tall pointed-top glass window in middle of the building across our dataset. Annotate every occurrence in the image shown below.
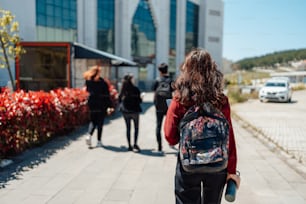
[131,0,156,65]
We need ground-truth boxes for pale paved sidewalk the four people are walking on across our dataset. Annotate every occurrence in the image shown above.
[0,93,306,204]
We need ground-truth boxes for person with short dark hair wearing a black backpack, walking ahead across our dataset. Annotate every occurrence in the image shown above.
[152,63,173,152]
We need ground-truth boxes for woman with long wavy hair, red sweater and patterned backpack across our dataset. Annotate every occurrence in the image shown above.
[164,49,240,204]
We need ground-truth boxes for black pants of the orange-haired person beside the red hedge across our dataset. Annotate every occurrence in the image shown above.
[88,110,105,141]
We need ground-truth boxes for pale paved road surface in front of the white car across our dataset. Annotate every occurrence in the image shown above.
[232,91,306,162]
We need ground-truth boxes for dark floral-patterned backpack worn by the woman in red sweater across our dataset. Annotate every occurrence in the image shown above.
[179,103,229,173]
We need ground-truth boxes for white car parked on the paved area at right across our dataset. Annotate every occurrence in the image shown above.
[258,78,292,102]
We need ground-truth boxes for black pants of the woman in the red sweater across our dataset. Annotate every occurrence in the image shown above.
[175,161,227,204]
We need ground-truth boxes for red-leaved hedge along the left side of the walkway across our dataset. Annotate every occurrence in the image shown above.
[0,88,89,158]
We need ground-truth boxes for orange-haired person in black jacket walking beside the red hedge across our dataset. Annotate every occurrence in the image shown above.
[83,66,113,147]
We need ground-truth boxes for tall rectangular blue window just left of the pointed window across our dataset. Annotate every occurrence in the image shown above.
[97,0,115,53]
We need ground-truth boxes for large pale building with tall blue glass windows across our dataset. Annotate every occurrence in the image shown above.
[0,0,224,90]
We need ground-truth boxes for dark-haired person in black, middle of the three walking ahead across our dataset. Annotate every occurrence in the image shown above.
[119,74,142,152]
